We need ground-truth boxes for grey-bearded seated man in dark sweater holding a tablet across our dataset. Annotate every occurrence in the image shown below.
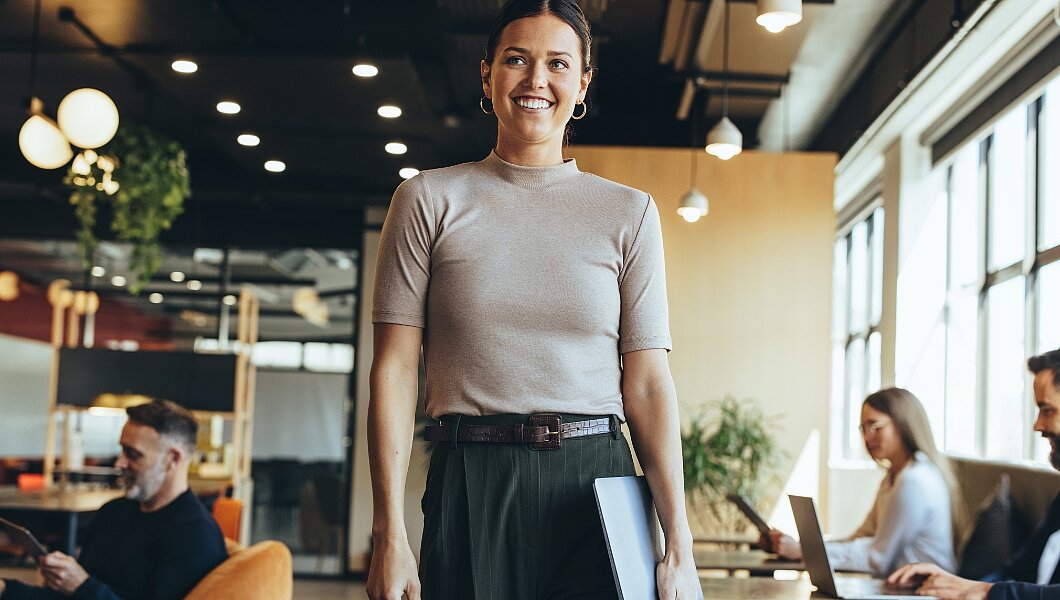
[0,401,227,600]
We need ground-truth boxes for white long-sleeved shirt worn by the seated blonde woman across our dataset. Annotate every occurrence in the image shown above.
[826,452,957,577]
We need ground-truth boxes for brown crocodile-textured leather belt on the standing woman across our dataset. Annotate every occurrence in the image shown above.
[423,412,619,449]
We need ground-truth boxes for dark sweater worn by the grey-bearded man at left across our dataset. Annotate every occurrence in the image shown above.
[2,491,227,600]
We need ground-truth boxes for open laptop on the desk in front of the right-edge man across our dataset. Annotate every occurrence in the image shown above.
[788,495,932,600]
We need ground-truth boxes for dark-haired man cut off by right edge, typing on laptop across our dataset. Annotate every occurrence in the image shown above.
[887,349,1060,600]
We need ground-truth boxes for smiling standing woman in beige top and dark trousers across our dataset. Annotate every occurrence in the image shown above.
[367,0,700,600]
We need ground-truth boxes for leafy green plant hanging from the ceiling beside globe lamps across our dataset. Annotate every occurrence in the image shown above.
[64,125,191,294]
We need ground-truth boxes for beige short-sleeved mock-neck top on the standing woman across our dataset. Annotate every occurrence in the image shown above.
[372,153,671,419]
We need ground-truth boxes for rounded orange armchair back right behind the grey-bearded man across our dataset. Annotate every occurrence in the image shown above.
[184,540,294,600]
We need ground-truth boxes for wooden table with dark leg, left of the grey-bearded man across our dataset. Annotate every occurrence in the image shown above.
[0,487,125,557]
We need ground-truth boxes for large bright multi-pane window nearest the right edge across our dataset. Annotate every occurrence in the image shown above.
[933,74,1060,459]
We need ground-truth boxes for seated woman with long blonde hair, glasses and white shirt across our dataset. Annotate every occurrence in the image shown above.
[761,388,957,577]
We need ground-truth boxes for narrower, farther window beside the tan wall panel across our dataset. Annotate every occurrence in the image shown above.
[831,205,883,458]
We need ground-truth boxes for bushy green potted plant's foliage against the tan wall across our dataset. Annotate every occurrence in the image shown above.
[681,396,784,532]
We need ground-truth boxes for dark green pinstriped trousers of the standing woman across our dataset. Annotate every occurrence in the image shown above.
[420,414,635,600]
